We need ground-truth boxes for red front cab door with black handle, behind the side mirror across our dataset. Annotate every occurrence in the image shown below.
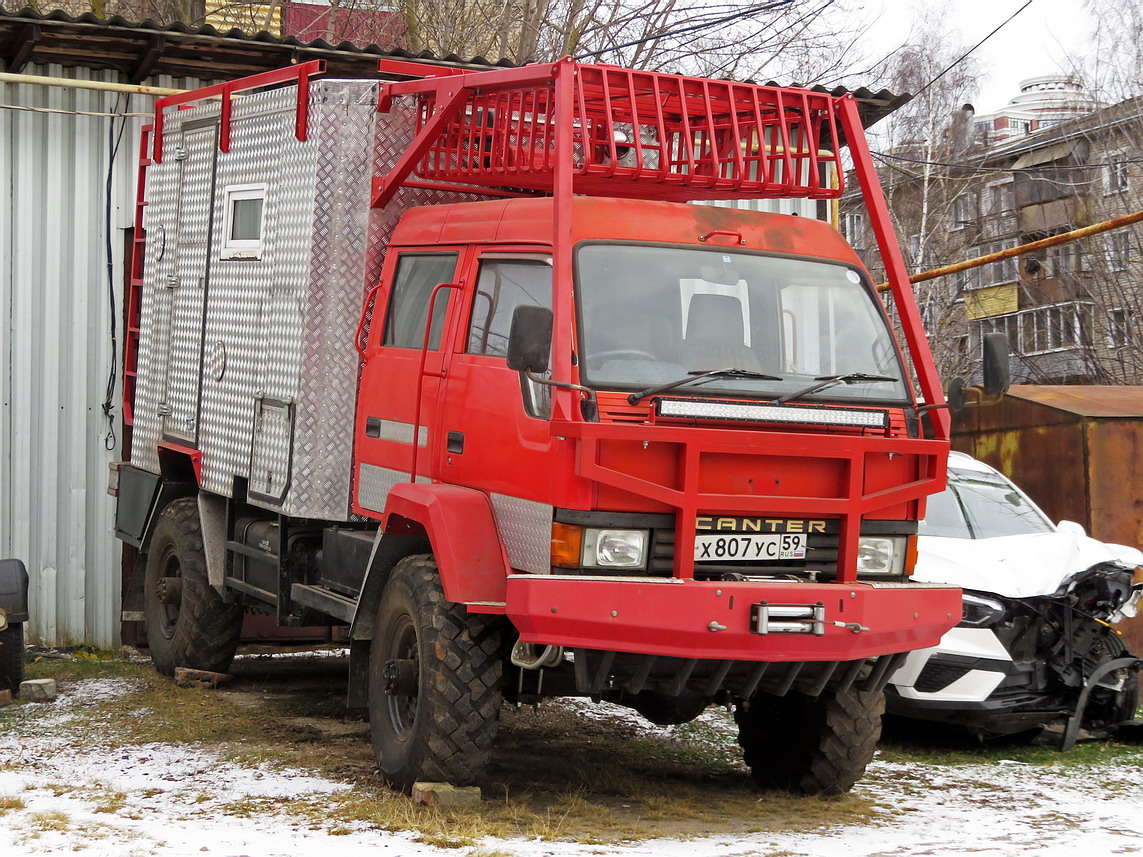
[434,249,553,572]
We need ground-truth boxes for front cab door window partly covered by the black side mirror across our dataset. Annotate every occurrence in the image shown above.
[467,258,552,357]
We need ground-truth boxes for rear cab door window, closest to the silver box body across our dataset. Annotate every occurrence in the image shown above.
[381,253,456,351]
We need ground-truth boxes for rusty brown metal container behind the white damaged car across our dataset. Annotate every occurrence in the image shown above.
[952,385,1143,655]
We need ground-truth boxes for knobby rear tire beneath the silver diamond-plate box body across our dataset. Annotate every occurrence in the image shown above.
[143,497,242,675]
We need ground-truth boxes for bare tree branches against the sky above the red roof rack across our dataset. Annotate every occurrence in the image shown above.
[403,0,862,82]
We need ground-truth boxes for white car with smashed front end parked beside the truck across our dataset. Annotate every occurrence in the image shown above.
[886,452,1143,738]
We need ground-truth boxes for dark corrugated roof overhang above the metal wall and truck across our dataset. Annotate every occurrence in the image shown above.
[0,8,911,128]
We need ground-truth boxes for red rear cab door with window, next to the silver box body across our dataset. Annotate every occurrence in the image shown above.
[355,248,462,513]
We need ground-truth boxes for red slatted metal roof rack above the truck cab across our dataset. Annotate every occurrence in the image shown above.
[374,59,844,206]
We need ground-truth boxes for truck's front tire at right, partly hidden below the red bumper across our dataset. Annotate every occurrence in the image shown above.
[734,690,885,795]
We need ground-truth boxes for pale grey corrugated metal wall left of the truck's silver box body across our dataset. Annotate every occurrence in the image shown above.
[0,65,211,647]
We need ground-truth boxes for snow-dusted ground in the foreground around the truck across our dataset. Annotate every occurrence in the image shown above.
[0,679,1143,857]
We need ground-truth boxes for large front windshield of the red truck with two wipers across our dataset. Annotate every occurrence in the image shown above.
[576,243,908,401]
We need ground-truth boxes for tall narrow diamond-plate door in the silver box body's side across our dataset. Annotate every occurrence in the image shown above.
[155,123,218,446]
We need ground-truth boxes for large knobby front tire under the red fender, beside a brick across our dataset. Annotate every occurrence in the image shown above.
[369,555,504,791]
